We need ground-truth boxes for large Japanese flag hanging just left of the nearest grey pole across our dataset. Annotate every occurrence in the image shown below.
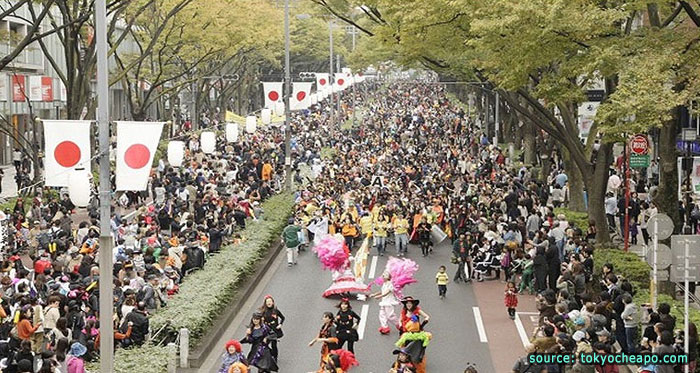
[42,120,92,187]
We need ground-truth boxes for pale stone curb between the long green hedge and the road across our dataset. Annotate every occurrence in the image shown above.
[185,241,282,371]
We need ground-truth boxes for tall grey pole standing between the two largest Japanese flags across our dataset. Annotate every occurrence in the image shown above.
[95,0,114,373]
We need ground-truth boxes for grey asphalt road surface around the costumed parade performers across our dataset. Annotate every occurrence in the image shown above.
[198,240,498,373]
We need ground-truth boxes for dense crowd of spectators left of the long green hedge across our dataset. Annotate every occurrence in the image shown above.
[0,91,296,373]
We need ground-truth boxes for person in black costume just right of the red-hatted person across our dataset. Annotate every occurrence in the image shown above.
[241,312,278,373]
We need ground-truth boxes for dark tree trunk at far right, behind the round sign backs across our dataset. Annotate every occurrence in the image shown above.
[652,108,683,233]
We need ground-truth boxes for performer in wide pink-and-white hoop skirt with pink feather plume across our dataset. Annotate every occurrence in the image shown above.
[313,235,369,297]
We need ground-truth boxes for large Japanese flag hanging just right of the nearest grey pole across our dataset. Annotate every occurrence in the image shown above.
[116,122,164,190]
